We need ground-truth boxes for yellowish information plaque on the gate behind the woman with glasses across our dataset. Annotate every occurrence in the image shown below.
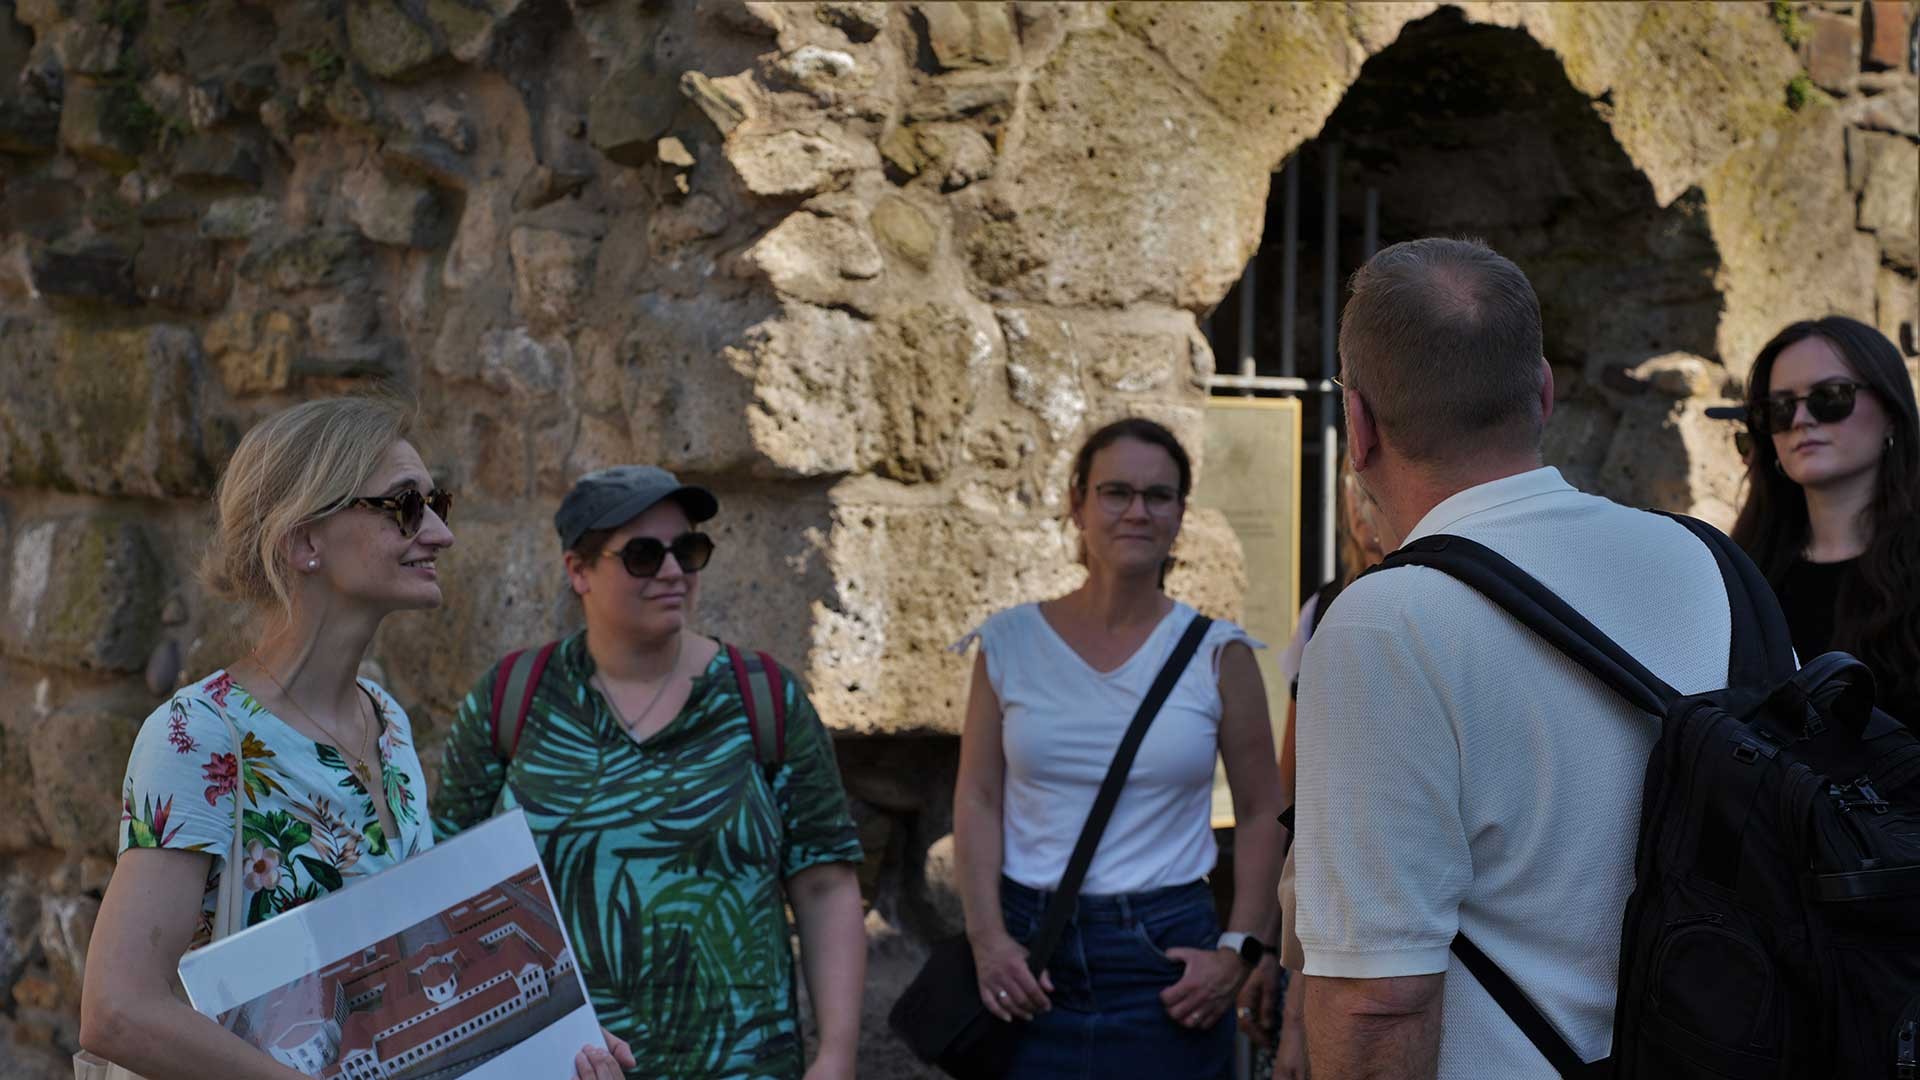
[1194,398,1304,828]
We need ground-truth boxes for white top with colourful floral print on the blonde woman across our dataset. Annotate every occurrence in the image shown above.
[119,671,434,944]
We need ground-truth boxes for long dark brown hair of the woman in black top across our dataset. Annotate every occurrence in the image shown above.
[1734,315,1920,707]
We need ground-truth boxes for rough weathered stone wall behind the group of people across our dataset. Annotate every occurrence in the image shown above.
[0,0,1920,1076]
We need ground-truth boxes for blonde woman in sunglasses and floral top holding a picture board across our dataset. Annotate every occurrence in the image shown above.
[81,398,630,1080]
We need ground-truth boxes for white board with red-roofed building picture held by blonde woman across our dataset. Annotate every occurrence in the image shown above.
[180,809,601,1080]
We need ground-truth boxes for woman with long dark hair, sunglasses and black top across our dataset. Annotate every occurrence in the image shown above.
[1734,315,1920,730]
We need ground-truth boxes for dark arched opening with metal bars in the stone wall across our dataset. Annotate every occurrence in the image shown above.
[1208,8,1720,596]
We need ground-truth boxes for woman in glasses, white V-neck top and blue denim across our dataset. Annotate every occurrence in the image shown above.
[954,419,1281,1078]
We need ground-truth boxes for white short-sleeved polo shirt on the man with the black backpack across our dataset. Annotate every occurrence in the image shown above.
[1294,469,1732,1080]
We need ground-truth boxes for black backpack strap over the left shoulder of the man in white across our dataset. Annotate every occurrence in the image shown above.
[1367,534,1678,717]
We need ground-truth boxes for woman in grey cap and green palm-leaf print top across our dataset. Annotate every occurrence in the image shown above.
[432,467,866,1080]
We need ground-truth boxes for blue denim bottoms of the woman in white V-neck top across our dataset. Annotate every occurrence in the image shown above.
[1000,878,1233,1080]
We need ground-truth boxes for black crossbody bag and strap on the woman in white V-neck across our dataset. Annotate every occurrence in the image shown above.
[887,615,1213,1080]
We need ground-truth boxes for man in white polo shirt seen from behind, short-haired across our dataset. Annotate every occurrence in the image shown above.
[1296,238,1732,1080]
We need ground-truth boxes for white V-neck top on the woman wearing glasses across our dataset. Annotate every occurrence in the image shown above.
[975,603,1265,896]
